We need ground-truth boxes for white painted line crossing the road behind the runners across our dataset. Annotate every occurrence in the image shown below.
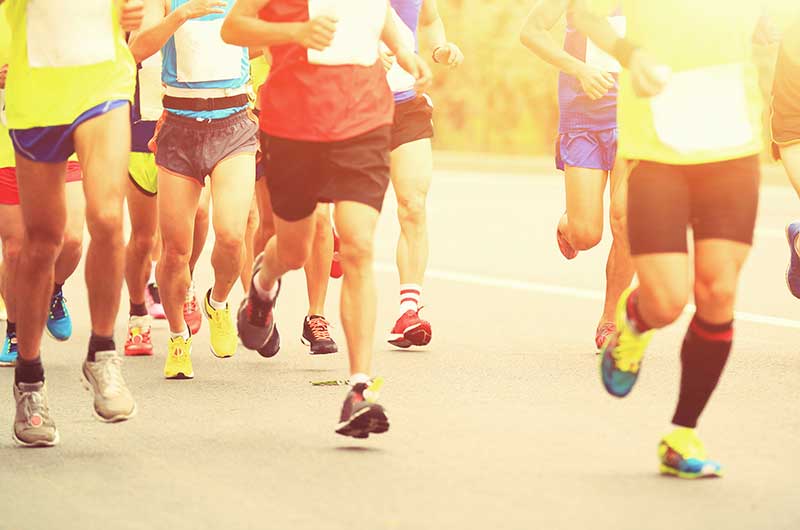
[375,262,800,329]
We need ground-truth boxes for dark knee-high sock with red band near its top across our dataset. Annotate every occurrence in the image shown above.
[672,315,733,428]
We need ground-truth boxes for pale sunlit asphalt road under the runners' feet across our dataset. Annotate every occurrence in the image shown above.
[0,172,800,530]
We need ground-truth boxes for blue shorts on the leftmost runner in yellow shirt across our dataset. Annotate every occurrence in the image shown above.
[9,99,129,163]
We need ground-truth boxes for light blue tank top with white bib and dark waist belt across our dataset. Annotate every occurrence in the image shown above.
[161,0,250,119]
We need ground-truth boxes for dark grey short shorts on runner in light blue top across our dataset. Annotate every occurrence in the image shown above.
[150,110,258,186]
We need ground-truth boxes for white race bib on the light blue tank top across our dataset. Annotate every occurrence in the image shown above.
[175,18,244,83]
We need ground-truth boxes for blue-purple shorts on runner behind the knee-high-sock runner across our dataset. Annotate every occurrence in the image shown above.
[556,129,617,171]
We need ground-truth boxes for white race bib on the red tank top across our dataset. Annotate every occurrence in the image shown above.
[308,0,388,66]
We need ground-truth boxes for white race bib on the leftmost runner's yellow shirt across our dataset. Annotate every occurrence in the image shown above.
[26,0,116,68]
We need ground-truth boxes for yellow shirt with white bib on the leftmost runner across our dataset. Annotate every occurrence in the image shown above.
[5,0,136,129]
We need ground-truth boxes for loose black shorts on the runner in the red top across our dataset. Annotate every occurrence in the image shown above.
[261,125,392,221]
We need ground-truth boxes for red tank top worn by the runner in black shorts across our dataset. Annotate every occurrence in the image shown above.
[259,0,394,142]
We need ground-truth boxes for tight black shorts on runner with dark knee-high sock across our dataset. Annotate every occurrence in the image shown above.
[628,156,761,256]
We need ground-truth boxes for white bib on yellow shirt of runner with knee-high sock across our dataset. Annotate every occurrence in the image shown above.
[650,63,754,154]
